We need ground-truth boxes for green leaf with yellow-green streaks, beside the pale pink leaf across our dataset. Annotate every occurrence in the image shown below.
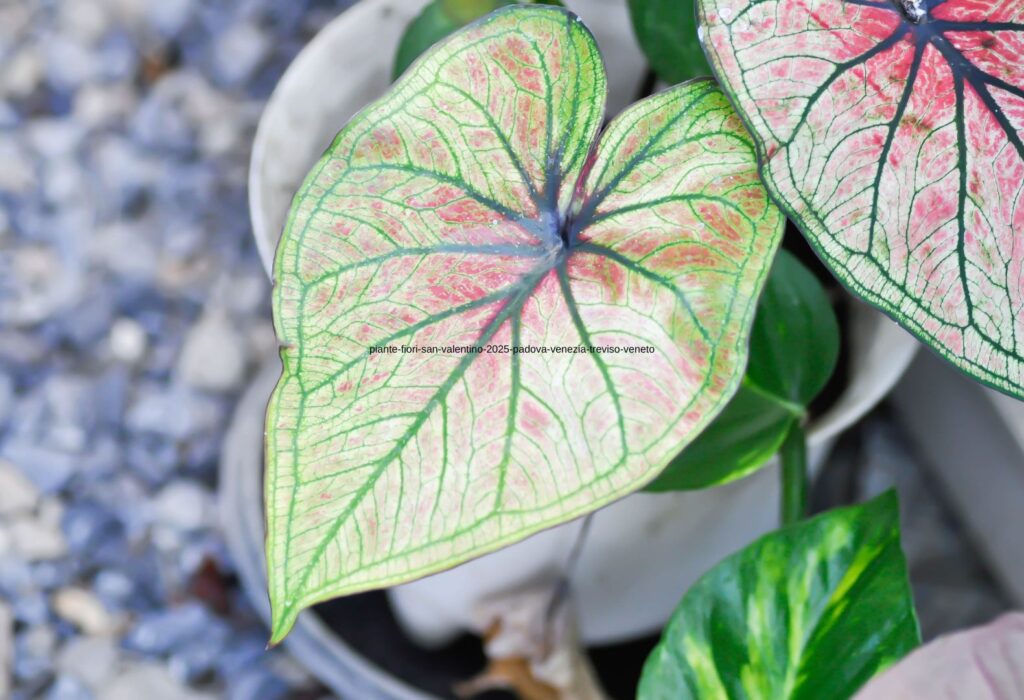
[637,492,921,700]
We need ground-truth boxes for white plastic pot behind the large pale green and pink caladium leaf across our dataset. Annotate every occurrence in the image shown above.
[249,0,918,663]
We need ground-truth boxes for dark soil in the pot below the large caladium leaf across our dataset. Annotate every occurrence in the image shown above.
[313,590,658,700]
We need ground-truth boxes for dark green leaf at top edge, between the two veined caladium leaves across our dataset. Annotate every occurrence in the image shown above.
[630,0,712,84]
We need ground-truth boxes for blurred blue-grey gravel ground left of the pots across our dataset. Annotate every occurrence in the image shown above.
[0,0,348,700]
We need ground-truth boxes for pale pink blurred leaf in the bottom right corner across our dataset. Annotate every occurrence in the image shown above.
[856,613,1024,700]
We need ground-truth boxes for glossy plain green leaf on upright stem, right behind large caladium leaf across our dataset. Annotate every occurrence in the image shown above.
[647,250,839,491]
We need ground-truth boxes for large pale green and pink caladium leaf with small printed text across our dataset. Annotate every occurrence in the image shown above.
[265,6,782,641]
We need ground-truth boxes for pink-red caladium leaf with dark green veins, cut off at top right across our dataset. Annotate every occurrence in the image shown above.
[698,0,1024,397]
